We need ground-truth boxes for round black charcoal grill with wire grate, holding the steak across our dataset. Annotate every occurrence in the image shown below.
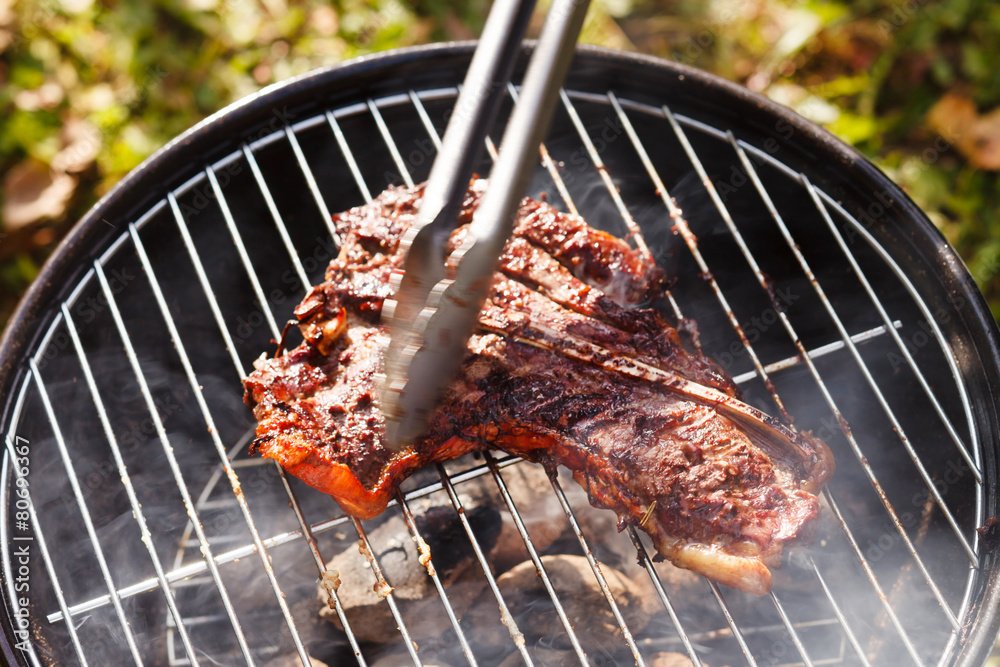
[0,44,1000,665]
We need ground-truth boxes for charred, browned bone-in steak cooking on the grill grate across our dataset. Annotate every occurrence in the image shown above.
[245,181,833,594]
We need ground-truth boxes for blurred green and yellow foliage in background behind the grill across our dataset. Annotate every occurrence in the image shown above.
[0,0,1000,325]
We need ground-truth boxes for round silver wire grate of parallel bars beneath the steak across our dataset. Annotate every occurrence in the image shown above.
[4,78,983,665]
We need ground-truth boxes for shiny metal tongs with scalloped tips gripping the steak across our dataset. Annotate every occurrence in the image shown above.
[382,0,590,452]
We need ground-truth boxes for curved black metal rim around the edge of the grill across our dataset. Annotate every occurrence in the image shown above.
[0,42,1000,666]
